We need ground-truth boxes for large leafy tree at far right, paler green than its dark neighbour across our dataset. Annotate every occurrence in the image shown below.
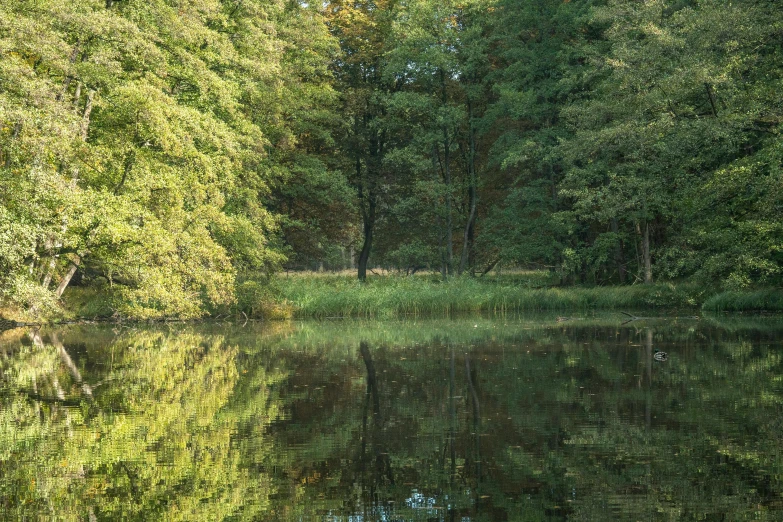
[561,0,781,286]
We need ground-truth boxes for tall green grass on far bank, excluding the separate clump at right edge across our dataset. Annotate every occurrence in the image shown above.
[274,276,699,318]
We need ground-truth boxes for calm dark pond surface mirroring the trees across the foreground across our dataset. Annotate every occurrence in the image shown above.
[0,314,783,522]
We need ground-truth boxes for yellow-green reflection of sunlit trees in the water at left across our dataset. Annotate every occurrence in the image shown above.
[0,331,280,520]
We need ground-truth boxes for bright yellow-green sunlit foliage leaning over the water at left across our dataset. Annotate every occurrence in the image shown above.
[0,0,335,318]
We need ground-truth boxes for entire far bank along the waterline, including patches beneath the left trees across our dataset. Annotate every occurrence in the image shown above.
[9,272,783,322]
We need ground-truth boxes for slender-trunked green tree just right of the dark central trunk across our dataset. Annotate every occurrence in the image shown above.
[378,1,489,276]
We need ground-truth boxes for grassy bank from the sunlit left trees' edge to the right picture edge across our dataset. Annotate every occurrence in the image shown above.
[270,271,783,318]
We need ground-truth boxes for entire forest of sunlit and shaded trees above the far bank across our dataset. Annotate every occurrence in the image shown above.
[0,0,783,319]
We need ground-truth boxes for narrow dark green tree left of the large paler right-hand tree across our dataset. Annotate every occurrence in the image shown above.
[480,0,603,280]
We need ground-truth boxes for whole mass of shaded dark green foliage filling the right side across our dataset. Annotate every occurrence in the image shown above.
[466,0,783,288]
